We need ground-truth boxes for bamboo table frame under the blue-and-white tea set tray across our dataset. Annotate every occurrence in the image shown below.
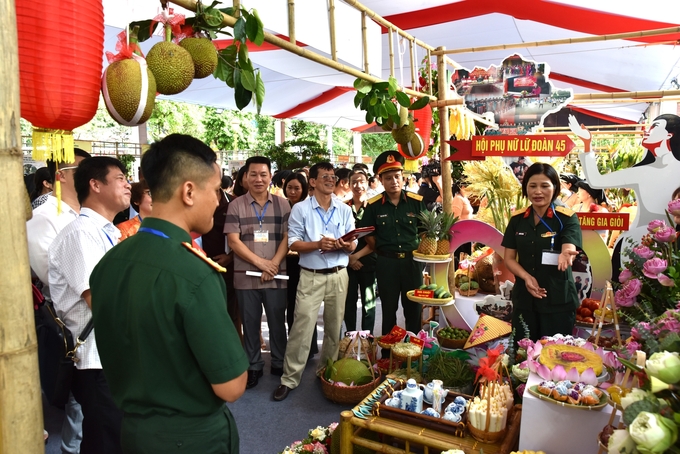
[340,405,520,454]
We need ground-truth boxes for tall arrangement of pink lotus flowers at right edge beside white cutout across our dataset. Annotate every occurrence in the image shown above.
[614,200,680,324]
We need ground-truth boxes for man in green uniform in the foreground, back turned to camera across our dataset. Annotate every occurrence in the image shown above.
[90,134,248,454]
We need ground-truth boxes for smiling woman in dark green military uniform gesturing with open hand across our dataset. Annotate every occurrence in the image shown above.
[502,163,581,340]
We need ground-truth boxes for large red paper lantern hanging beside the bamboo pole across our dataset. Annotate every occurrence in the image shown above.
[16,0,104,161]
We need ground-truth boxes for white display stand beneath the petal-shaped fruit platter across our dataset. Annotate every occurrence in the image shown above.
[516,373,620,454]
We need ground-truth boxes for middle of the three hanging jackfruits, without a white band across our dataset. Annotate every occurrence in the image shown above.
[146,41,194,95]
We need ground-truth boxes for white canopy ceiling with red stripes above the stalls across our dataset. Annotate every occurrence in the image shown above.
[104,0,680,128]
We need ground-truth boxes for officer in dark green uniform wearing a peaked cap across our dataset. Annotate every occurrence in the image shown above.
[357,151,426,334]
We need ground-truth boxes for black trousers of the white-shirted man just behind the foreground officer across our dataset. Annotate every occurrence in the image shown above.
[71,369,123,454]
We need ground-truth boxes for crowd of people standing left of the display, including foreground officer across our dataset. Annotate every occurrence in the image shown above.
[27,140,454,454]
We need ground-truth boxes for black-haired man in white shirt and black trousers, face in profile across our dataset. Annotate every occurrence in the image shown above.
[48,157,130,454]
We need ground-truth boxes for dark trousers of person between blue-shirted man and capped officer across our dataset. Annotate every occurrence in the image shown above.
[345,268,376,334]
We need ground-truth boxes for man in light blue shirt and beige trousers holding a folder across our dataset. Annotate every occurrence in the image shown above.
[274,162,357,401]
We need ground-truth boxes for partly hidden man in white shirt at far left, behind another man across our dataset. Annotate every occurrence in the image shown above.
[26,148,90,454]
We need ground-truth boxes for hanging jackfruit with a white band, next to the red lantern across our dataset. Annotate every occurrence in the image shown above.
[102,59,156,126]
